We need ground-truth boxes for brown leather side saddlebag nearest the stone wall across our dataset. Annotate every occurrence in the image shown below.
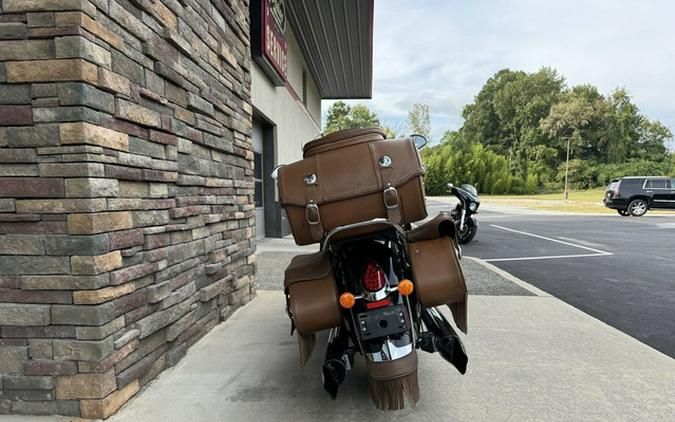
[284,251,342,366]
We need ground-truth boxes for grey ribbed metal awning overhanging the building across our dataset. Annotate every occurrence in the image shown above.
[286,0,374,99]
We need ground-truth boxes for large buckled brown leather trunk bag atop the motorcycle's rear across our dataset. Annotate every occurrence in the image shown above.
[279,129,427,245]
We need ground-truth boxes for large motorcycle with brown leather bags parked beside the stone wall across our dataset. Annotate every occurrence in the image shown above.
[278,129,468,410]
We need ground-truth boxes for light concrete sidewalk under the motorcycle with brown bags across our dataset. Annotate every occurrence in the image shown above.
[6,241,675,422]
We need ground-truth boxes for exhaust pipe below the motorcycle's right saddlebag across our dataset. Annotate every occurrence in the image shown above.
[422,308,469,375]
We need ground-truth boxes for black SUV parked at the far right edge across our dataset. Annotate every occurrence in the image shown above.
[603,176,675,217]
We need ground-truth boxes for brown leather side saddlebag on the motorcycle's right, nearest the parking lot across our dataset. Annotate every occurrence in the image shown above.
[407,213,468,333]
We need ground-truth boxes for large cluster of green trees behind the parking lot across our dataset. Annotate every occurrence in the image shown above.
[422,68,675,195]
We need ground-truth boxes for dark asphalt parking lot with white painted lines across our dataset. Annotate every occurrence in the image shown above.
[430,202,675,357]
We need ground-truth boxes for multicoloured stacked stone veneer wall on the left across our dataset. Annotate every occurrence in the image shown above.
[0,0,255,418]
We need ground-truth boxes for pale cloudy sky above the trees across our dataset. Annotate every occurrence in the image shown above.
[323,0,675,147]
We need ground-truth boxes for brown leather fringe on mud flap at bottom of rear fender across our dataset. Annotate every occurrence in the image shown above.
[368,369,420,410]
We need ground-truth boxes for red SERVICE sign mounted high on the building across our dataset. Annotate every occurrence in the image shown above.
[251,0,288,85]
